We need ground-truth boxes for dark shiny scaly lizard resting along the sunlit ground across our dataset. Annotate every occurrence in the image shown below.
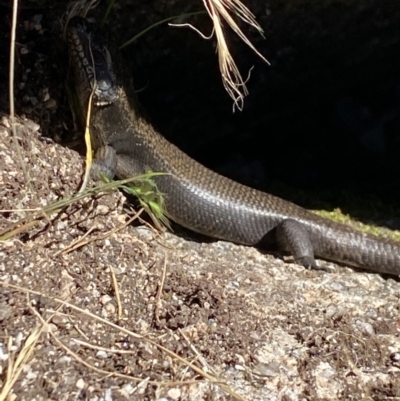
[67,18,400,275]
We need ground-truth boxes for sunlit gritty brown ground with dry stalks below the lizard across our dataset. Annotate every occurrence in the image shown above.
[0,118,400,400]
